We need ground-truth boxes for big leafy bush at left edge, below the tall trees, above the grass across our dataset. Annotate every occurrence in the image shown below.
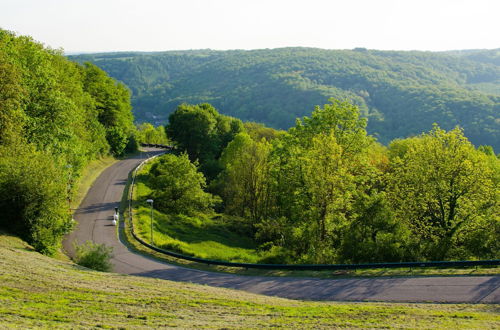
[0,145,71,254]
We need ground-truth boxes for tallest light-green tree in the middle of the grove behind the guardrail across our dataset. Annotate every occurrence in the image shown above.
[266,100,390,263]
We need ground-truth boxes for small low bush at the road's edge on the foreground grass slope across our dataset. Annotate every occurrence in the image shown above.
[75,241,113,272]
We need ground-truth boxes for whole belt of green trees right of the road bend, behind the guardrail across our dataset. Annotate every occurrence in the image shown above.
[154,99,500,263]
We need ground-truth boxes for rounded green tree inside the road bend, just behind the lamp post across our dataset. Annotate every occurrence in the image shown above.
[149,154,218,215]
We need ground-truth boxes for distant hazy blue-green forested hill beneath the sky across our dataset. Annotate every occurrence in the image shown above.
[70,48,500,152]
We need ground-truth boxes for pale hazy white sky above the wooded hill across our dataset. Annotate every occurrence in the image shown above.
[0,0,500,52]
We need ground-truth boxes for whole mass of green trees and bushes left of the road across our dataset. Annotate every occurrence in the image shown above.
[0,30,137,254]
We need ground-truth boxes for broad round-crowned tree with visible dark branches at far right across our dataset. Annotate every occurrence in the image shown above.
[387,126,499,260]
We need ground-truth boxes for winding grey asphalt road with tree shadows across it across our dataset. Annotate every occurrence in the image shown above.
[64,149,500,303]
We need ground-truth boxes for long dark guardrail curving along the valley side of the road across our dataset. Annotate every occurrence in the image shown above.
[129,155,500,271]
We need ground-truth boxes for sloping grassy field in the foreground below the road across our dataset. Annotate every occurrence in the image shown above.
[0,233,500,329]
